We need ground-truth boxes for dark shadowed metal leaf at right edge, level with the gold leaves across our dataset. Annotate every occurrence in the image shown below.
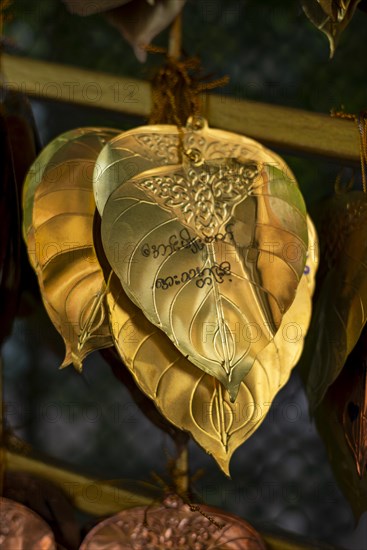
[302,191,367,411]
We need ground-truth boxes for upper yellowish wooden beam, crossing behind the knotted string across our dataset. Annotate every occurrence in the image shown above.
[2,54,359,163]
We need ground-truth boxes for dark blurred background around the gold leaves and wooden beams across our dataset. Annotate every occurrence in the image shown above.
[3,0,367,550]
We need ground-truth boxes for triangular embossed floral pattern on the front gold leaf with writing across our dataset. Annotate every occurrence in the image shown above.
[136,159,259,239]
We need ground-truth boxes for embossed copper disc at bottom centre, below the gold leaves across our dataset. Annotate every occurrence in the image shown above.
[80,496,266,550]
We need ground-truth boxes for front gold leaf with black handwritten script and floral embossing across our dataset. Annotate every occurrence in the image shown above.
[99,121,308,401]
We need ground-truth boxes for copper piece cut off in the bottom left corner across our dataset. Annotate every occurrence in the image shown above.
[0,497,56,550]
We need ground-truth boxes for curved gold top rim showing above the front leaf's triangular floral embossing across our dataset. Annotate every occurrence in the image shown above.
[93,119,295,216]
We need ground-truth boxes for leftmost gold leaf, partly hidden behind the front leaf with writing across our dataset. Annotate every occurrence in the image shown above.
[23,128,117,370]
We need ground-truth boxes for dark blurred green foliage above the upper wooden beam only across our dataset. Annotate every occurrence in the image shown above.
[5,0,367,112]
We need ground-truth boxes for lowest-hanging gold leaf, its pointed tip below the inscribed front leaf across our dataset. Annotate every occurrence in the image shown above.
[107,221,318,474]
